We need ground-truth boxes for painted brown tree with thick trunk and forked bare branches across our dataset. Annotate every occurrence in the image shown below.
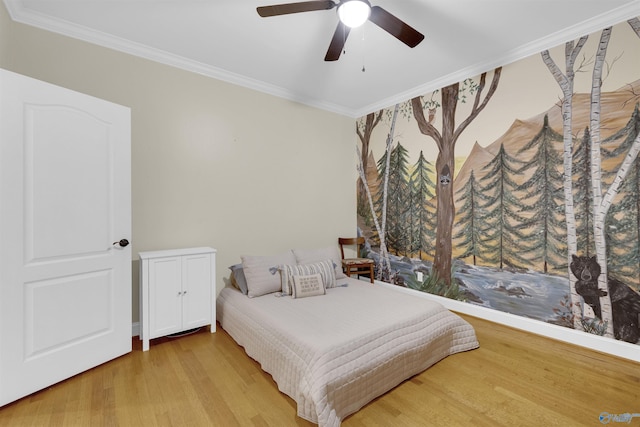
[411,67,502,287]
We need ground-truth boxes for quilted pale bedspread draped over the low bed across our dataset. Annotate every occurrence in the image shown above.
[217,279,478,427]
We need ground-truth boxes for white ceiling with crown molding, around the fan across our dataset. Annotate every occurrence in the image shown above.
[4,0,640,117]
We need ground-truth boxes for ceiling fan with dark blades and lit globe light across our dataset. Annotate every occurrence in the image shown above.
[256,0,424,61]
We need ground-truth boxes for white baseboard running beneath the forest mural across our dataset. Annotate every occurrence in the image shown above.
[376,281,640,362]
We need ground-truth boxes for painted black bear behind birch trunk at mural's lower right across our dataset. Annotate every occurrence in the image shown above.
[570,255,640,344]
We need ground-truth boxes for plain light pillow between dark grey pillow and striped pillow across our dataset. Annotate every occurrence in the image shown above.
[240,251,296,298]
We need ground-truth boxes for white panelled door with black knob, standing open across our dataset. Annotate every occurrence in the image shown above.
[0,70,131,405]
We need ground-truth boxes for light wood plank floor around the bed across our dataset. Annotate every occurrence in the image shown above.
[0,316,640,427]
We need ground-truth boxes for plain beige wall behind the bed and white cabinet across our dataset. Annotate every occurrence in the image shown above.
[0,4,356,321]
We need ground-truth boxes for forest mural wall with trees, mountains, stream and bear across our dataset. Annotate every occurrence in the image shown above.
[357,18,640,344]
